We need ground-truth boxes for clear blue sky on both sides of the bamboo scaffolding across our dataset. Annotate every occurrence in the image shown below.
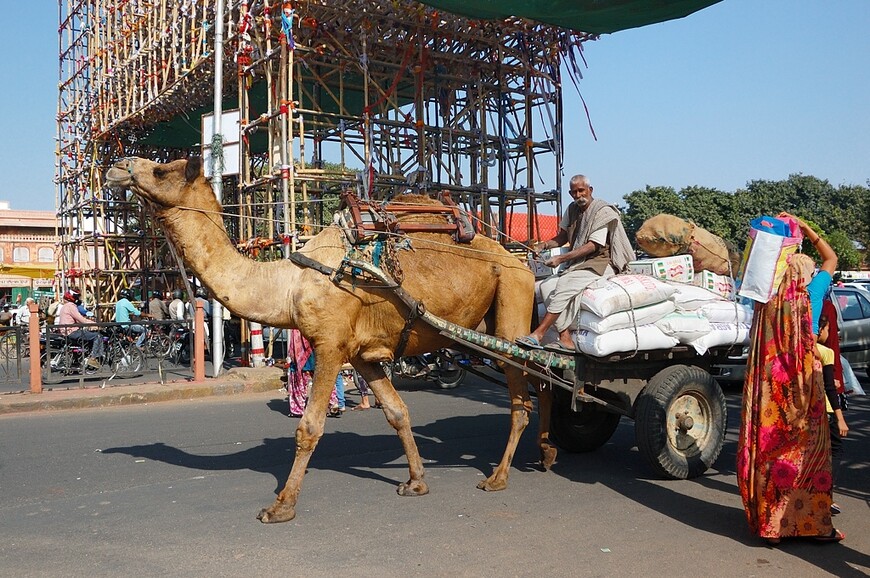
[0,0,870,210]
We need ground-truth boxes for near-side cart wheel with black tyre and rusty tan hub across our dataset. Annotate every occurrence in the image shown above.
[634,365,727,480]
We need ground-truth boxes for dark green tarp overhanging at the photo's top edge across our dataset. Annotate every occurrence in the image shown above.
[421,0,721,34]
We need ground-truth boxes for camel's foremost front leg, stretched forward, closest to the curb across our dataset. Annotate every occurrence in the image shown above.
[257,349,341,524]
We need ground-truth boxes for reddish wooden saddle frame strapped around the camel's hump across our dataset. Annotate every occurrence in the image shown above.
[337,191,475,244]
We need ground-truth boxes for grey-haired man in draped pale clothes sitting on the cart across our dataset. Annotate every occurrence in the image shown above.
[517,175,635,353]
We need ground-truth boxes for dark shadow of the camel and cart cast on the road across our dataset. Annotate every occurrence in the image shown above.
[103,372,870,576]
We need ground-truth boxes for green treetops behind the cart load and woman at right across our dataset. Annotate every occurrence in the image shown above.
[623,174,870,270]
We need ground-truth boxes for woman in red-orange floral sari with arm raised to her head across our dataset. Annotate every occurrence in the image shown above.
[737,215,845,544]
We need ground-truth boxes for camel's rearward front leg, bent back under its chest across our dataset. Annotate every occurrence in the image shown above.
[353,360,429,496]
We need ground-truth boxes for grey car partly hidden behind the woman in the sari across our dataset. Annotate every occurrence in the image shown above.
[710,286,870,383]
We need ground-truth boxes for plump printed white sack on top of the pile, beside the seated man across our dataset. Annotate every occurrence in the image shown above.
[580,275,677,317]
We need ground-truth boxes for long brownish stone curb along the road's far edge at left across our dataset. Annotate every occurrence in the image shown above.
[0,367,284,415]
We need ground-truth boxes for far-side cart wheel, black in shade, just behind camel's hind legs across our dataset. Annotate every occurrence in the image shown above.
[550,389,620,453]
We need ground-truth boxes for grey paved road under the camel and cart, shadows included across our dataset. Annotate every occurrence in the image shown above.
[0,377,870,578]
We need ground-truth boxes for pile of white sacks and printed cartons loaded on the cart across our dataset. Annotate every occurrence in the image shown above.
[574,255,752,357]
